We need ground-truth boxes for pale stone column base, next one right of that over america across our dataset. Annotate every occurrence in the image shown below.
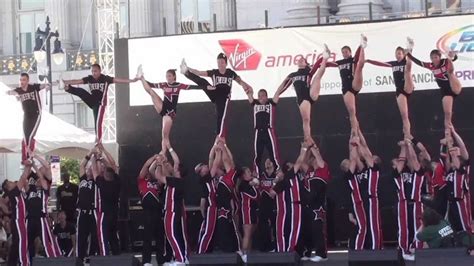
[337,0,384,19]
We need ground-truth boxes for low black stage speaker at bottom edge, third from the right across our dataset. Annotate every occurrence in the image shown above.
[247,252,299,265]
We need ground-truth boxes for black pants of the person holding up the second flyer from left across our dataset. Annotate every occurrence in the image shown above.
[76,210,98,259]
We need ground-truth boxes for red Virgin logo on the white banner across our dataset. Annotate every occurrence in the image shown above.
[219,39,262,70]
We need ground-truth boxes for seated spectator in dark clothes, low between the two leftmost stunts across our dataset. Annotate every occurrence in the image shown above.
[53,211,76,257]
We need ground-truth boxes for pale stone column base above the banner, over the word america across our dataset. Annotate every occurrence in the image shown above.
[285,0,330,26]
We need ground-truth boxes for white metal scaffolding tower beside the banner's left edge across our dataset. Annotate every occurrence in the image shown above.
[96,0,120,142]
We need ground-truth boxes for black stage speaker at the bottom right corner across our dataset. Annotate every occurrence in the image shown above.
[415,248,474,266]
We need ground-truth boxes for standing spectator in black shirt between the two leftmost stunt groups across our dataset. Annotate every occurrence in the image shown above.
[56,173,79,223]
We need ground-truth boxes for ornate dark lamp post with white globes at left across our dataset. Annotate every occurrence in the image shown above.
[33,16,64,113]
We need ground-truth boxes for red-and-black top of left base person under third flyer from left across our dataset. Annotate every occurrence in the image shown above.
[138,178,163,210]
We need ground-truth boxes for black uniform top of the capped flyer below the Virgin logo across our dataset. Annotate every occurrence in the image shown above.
[206,68,239,102]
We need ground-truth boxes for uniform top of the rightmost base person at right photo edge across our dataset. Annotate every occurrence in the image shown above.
[445,160,470,200]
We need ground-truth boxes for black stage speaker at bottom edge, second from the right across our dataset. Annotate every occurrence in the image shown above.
[349,249,404,266]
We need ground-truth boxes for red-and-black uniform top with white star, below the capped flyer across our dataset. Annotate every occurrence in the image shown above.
[216,169,236,219]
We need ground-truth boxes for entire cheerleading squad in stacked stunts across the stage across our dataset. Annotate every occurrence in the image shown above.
[0,31,472,265]
